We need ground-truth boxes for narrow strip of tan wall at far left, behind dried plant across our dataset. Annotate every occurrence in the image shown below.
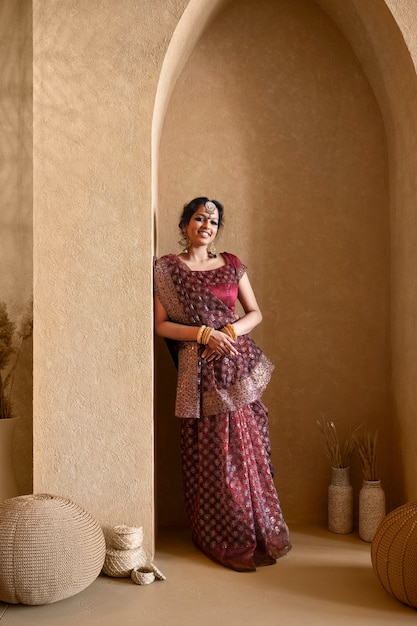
[0,0,32,493]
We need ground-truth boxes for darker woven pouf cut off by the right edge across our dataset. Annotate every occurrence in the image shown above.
[371,502,417,608]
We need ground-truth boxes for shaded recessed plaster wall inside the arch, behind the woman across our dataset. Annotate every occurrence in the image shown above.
[156,0,392,523]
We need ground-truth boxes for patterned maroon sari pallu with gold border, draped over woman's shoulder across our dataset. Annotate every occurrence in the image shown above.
[154,253,274,418]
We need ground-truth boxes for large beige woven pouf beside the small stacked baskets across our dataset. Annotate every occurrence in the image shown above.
[0,494,106,605]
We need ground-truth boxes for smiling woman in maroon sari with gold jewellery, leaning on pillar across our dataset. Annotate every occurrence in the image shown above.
[155,197,291,571]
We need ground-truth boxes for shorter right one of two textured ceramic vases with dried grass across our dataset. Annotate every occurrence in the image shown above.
[359,480,386,542]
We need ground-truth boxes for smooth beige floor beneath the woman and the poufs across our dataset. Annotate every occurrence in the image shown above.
[0,527,417,626]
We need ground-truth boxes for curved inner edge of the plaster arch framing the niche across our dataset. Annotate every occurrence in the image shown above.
[152,0,417,528]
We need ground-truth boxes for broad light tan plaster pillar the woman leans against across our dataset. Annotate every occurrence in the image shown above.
[33,0,183,550]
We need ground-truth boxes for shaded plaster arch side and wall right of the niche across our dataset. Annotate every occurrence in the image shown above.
[320,0,417,504]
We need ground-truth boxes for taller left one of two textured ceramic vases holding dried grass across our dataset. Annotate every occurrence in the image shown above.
[328,467,353,535]
